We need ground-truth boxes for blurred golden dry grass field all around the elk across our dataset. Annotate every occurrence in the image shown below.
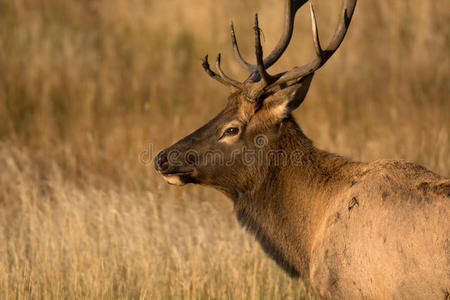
[0,0,450,299]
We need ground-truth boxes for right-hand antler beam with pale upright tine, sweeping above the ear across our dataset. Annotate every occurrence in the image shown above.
[275,0,356,85]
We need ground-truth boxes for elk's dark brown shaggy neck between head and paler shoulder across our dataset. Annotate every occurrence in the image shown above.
[229,117,358,278]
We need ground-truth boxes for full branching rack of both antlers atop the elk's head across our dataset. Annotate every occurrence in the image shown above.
[203,0,356,101]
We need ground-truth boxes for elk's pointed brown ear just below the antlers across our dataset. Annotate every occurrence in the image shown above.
[263,73,314,120]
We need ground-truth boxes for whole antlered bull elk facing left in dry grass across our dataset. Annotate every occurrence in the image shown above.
[155,0,450,299]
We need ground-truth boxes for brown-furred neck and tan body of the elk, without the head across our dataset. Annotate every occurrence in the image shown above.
[244,120,450,299]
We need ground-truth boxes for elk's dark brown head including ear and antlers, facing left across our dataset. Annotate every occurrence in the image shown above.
[155,0,356,195]
